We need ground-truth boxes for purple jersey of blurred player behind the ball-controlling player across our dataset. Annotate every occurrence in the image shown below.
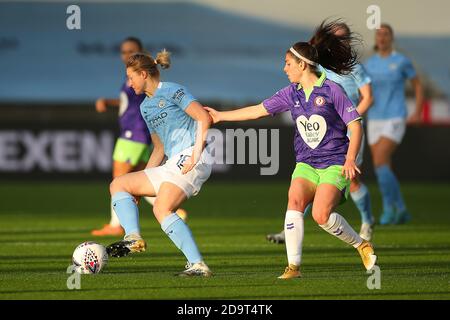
[119,82,150,144]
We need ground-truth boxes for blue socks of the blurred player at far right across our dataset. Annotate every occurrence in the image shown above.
[375,165,406,212]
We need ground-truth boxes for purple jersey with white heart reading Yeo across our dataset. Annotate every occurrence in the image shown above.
[263,74,361,169]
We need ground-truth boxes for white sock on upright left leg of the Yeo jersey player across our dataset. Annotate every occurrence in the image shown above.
[284,210,304,266]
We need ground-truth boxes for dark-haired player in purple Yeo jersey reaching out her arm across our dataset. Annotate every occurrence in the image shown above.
[207,22,377,279]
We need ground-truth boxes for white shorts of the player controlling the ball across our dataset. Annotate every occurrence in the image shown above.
[144,147,212,198]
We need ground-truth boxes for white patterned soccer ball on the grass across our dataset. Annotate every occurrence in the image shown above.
[72,241,108,274]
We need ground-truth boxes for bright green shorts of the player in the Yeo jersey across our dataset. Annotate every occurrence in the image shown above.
[292,162,350,203]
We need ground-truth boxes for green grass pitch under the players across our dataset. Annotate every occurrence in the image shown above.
[0,180,450,299]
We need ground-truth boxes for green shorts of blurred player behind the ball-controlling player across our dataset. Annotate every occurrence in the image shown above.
[113,138,151,167]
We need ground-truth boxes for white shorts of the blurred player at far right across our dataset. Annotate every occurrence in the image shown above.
[367,118,406,145]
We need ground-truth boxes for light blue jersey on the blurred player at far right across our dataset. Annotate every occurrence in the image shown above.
[364,51,416,120]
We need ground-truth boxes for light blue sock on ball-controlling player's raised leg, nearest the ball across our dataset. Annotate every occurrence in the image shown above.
[111,192,139,234]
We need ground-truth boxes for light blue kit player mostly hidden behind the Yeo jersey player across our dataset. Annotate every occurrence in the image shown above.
[267,22,375,243]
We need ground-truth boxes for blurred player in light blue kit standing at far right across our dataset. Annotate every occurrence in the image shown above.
[365,24,423,224]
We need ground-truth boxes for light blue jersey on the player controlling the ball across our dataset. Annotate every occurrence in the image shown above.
[141,82,197,158]
